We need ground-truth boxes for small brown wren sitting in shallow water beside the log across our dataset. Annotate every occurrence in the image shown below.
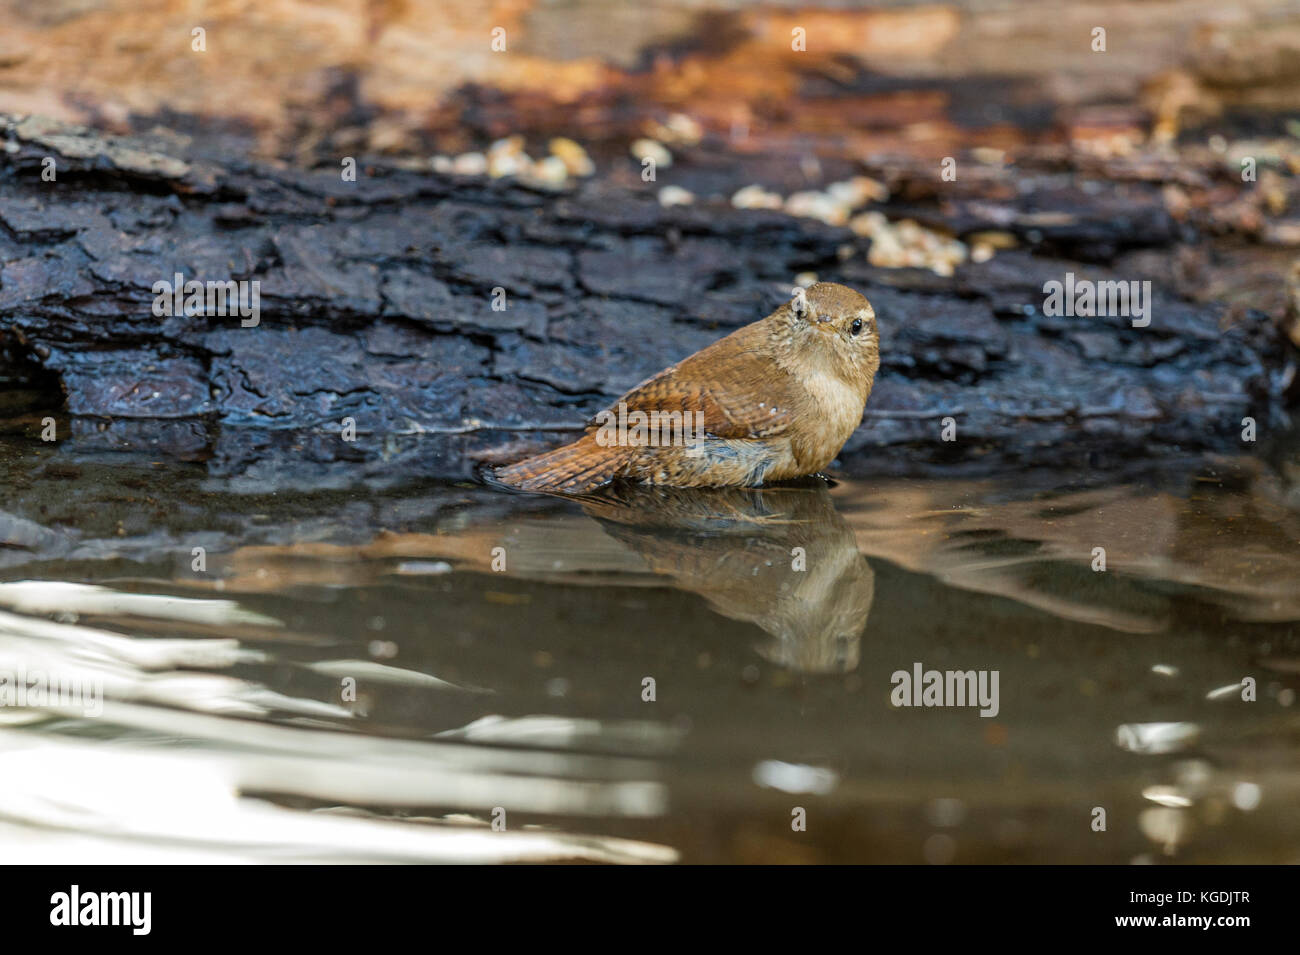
[495,282,880,494]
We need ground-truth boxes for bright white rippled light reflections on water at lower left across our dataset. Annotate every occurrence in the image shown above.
[0,582,676,863]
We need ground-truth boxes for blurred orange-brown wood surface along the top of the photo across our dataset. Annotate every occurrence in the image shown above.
[0,0,1300,156]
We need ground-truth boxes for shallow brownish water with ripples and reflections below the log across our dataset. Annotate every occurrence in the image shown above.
[0,439,1300,863]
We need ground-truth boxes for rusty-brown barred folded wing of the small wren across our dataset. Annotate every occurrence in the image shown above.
[592,325,794,438]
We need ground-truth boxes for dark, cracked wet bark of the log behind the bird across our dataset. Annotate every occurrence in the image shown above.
[0,113,1294,483]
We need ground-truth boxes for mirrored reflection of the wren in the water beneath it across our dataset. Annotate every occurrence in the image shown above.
[581,479,875,673]
